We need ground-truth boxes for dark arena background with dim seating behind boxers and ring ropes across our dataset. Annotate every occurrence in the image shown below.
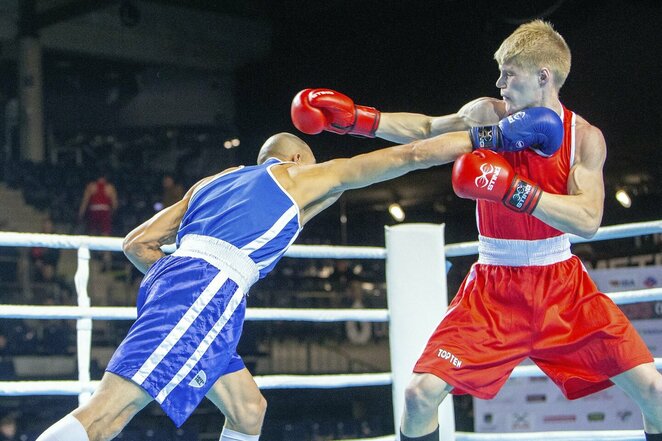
[0,0,662,441]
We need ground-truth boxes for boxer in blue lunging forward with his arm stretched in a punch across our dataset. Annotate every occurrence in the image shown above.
[38,118,560,441]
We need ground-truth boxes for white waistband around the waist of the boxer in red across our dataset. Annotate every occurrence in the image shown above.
[478,234,572,266]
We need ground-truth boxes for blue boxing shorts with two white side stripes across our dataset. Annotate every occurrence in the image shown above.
[106,234,257,427]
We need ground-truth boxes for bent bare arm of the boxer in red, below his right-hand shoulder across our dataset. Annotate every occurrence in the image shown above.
[533,124,607,238]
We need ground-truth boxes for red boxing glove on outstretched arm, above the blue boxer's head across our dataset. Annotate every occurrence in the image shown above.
[290,89,381,138]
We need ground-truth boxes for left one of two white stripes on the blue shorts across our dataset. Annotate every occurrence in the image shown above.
[131,271,228,385]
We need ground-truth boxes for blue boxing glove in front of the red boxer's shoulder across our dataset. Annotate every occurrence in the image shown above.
[469,107,563,156]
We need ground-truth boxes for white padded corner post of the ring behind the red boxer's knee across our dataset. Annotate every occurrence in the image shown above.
[386,224,455,441]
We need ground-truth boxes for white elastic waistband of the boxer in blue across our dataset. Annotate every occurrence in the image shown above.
[172,234,260,291]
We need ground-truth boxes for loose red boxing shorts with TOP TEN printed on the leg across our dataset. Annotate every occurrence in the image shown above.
[414,238,653,399]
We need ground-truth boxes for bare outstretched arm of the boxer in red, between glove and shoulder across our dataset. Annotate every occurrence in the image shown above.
[375,98,505,143]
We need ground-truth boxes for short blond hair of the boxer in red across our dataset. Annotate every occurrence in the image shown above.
[494,20,571,89]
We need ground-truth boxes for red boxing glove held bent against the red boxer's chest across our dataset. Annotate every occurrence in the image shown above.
[452,149,542,214]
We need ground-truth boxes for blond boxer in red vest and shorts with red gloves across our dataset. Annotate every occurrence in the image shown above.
[292,20,662,441]
